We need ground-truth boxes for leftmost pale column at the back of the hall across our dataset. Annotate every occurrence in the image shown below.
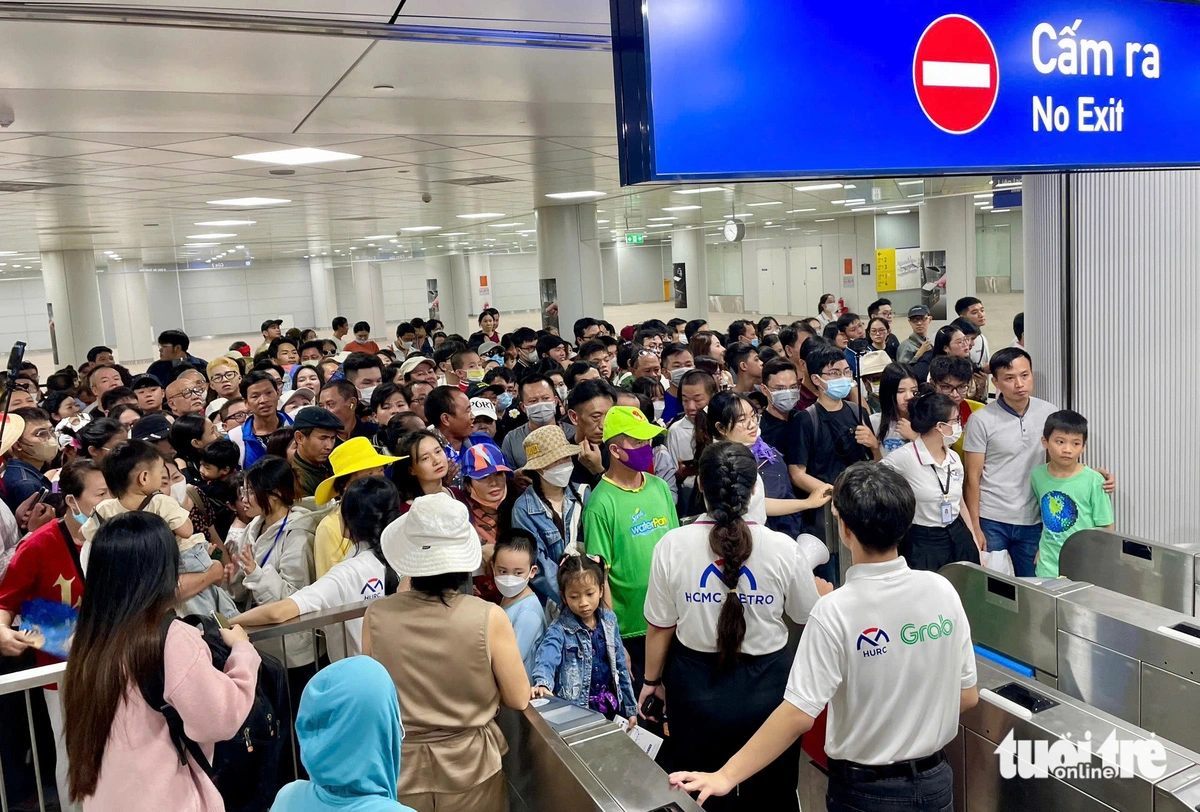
[42,251,104,367]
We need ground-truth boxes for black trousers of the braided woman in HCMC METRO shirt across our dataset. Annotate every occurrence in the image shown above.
[664,642,800,812]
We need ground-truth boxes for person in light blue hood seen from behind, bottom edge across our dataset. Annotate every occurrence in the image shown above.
[271,656,413,812]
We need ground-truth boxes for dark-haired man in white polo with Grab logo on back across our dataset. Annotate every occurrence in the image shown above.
[671,463,979,812]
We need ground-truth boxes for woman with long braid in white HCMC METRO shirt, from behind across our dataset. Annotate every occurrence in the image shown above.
[638,443,832,810]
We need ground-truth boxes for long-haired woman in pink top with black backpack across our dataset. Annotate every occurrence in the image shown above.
[62,511,259,812]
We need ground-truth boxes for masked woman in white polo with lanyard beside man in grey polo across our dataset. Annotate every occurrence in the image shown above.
[883,392,980,572]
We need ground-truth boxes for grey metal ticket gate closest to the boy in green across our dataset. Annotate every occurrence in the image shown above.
[1058,530,1200,616]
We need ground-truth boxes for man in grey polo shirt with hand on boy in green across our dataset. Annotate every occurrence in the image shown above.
[962,347,1115,576]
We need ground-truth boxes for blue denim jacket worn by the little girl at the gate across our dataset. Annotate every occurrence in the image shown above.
[533,608,637,716]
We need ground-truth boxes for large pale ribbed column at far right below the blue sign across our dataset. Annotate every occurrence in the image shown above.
[1024,172,1200,542]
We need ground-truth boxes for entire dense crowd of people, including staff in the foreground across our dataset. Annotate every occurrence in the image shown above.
[0,295,1114,812]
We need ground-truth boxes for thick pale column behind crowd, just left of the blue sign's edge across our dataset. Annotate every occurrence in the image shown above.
[536,203,604,333]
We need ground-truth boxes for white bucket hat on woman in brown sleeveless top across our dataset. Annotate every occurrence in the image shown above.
[379,493,484,578]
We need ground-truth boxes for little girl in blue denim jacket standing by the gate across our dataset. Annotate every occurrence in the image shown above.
[533,555,637,718]
